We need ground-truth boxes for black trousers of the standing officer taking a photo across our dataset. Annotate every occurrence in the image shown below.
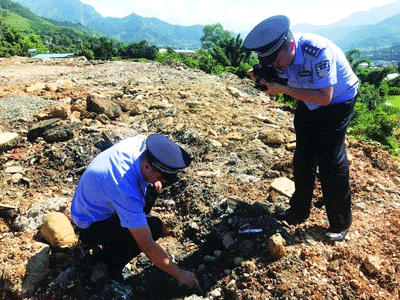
[290,96,357,231]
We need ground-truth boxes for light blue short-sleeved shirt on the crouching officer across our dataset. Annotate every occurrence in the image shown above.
[71,135,148,229]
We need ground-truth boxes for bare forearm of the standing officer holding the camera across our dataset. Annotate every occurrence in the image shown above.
[265,82,333,106]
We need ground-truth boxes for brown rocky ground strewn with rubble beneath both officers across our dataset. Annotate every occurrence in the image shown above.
[0,57,400,299]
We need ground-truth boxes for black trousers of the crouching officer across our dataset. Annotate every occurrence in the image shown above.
[79,215,162,280]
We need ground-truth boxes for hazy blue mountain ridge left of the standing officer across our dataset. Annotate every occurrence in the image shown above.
[15,0,204,49]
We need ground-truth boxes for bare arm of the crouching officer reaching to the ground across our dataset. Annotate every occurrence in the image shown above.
[129,225,199,289]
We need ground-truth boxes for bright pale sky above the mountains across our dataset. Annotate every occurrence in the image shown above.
[81,0,396,32]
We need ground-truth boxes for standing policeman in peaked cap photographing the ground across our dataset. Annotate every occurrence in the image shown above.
[244,16,358,241]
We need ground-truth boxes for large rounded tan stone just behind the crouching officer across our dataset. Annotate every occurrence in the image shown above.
[40,212,78,248]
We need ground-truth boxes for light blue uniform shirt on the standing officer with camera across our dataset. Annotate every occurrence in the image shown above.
[279,34,358,110]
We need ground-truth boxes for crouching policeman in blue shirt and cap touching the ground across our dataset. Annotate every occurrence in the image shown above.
[71,134,199,289]
